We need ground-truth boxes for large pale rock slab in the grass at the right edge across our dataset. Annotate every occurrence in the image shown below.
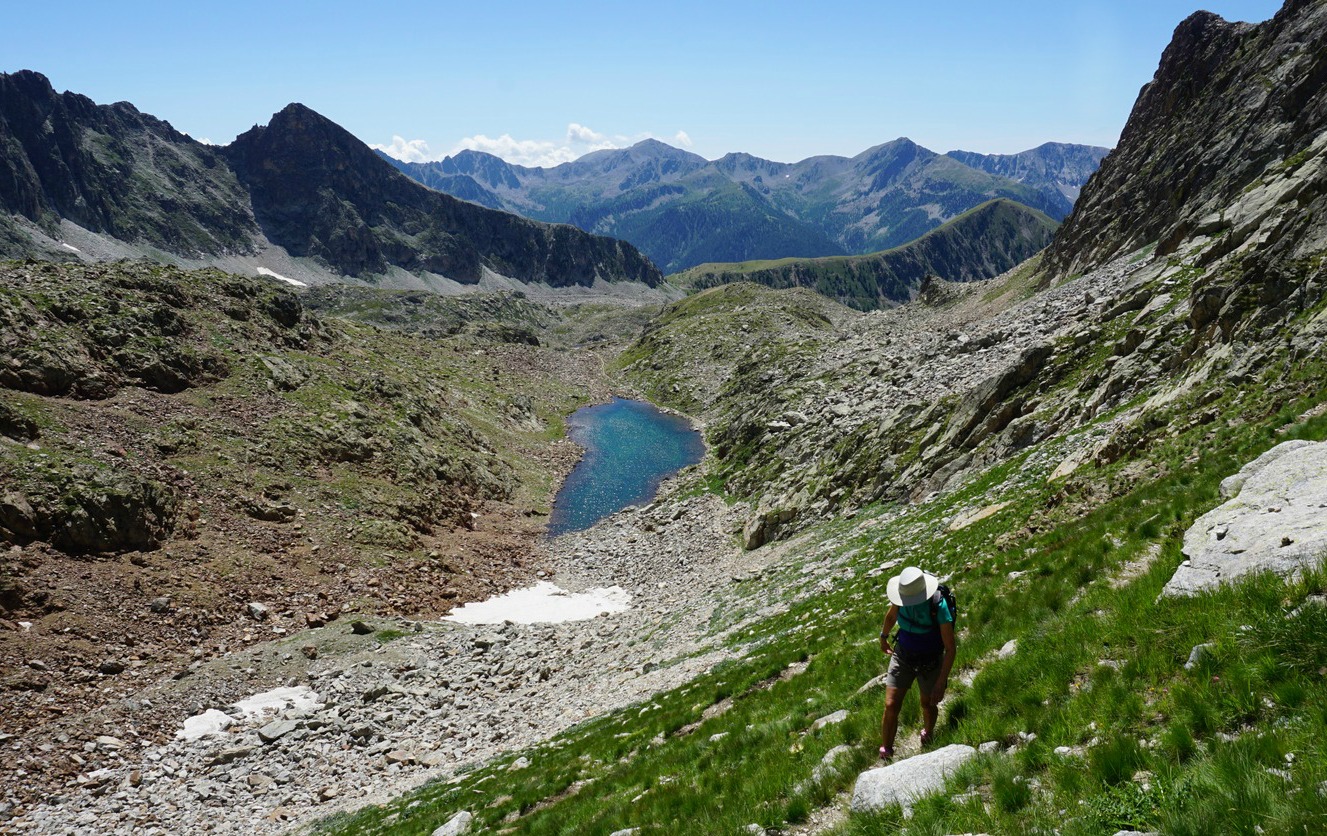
[1161,441,1327,596]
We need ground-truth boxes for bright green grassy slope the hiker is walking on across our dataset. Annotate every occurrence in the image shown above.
[315,258,1327,833]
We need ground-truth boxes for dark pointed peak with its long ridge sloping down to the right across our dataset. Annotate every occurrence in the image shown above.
[226,105,661,287]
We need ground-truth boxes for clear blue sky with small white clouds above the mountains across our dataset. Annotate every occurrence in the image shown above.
[0,0,1281,165]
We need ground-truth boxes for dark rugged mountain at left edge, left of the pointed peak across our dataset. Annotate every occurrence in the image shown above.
[0,72,257,256]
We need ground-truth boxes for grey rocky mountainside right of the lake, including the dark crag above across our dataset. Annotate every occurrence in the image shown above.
[626,3,1327,547]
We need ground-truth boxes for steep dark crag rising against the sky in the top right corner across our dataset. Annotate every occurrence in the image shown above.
[1048,0,1327,275]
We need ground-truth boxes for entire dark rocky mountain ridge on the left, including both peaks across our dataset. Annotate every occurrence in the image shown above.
[0,72,662,294]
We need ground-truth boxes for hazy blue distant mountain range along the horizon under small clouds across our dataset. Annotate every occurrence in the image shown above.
[384,138,1108,272]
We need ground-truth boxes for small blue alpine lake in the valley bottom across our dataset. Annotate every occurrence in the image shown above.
[548,398,705,537]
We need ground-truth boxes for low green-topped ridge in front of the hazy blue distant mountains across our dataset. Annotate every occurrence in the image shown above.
[670,199,1059,311]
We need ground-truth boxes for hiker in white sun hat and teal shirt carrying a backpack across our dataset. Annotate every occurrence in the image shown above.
[880,567,957,760]
